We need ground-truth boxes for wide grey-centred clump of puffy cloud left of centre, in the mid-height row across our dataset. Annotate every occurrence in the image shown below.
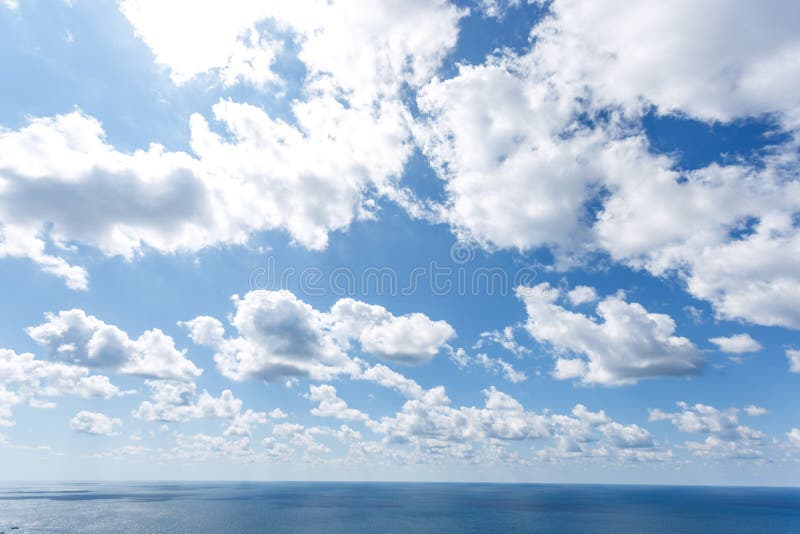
[183,290,455,381]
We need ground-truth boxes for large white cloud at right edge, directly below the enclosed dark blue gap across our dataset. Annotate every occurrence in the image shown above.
[595,163,800,328]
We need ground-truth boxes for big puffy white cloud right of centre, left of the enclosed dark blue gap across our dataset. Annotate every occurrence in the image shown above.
[416,56,606,255]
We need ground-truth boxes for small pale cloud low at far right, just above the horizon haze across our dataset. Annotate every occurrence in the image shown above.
[650,402,766,459]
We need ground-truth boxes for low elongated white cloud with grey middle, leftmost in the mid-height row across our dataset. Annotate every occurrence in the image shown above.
[26,309,203,380]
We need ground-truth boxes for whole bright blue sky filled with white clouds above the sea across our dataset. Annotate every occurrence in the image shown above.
[0,0,800,485]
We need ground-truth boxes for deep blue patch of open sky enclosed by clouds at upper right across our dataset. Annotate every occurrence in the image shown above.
[642,112,790,170]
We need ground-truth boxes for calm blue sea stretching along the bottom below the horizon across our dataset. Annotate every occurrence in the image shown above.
[0,482,800,534]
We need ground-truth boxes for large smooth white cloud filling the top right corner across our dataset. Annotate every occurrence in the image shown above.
[533,0,800,121]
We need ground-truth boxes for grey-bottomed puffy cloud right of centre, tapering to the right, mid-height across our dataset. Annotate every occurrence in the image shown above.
[517,283,703,385]
